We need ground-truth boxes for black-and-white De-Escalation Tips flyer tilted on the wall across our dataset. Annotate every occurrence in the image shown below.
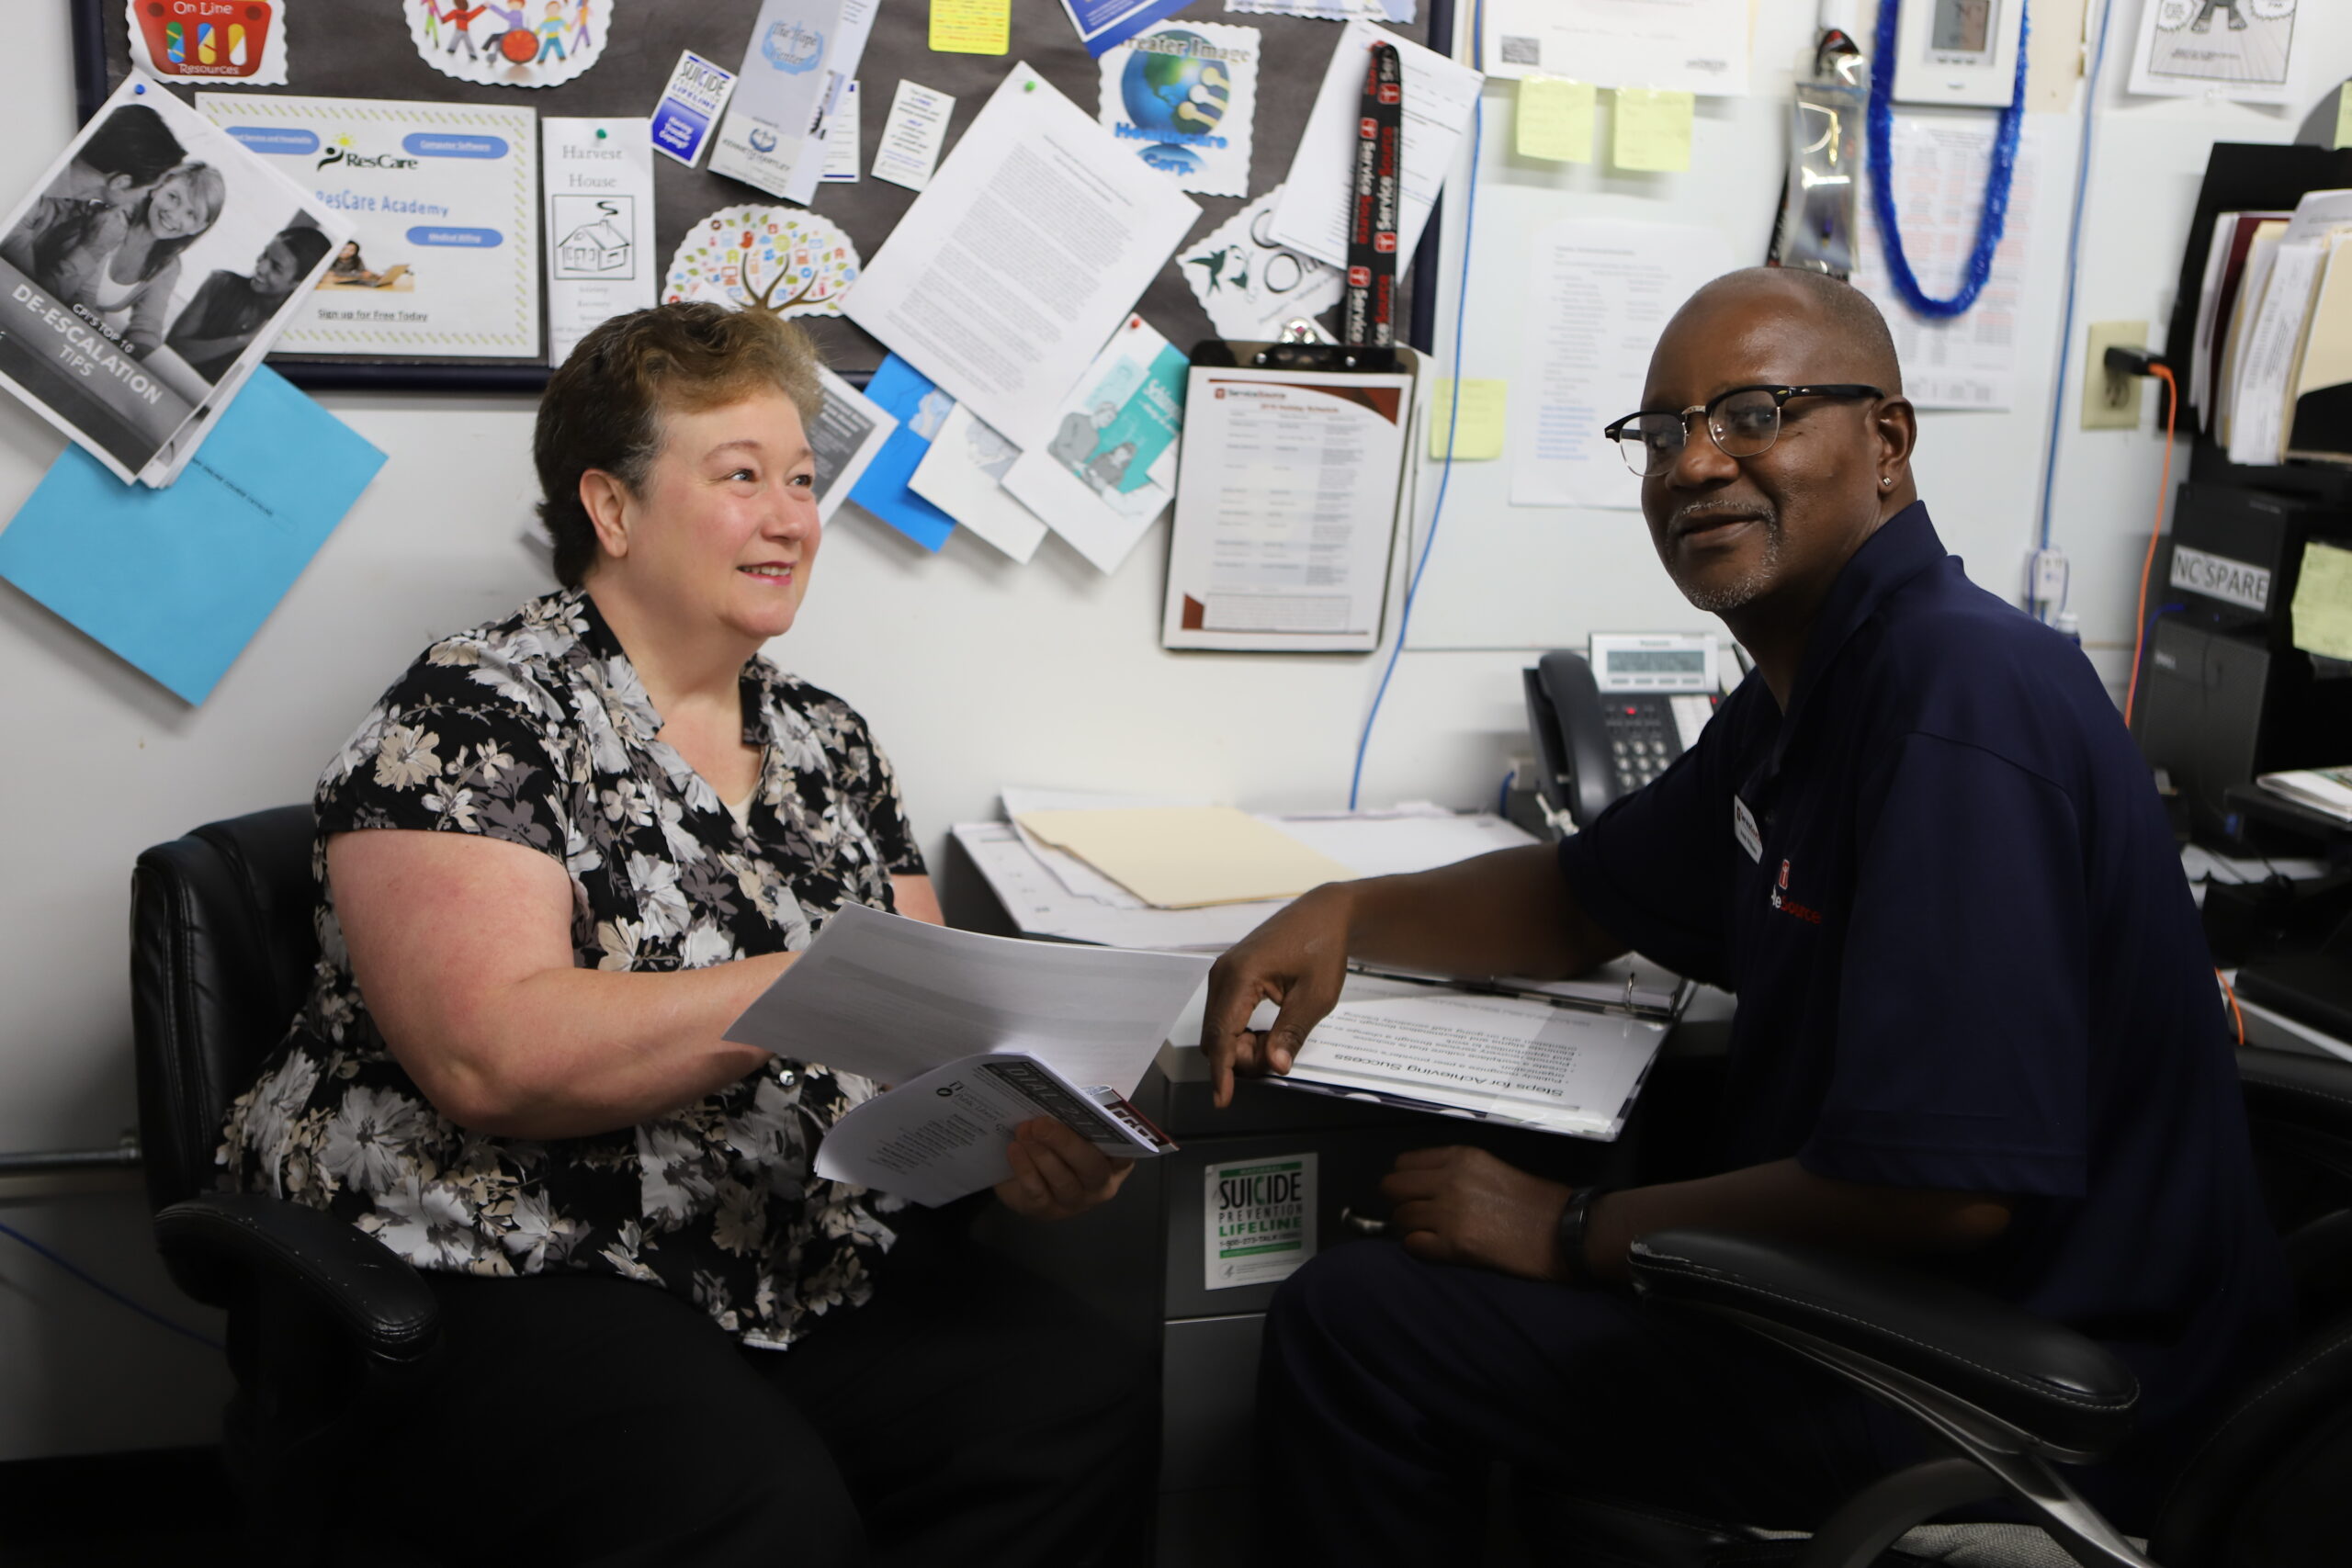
[0,73,350,482]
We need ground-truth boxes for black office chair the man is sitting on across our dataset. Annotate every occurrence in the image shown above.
[1524,1048,2352,1568]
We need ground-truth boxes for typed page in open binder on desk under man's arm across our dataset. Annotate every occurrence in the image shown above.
[1277,995,1668,1138]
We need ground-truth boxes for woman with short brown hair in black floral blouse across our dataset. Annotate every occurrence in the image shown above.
[223,303,1158,1563]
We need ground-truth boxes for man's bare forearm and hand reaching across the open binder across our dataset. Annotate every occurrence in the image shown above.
[1200,844,1625,1105]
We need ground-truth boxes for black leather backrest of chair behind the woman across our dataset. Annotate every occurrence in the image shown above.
[131,804,318,1208]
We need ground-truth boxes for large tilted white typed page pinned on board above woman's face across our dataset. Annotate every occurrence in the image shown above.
[842,66,1200,451]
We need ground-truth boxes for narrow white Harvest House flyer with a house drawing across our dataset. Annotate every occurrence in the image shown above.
[538,118,654,365]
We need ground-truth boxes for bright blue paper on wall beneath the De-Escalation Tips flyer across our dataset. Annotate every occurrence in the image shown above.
[0,367,383,703]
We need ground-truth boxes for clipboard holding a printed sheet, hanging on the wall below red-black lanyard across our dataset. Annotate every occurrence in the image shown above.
[1159,339,1420,653]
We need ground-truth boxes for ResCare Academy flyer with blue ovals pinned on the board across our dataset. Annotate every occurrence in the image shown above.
[198,92,543,360]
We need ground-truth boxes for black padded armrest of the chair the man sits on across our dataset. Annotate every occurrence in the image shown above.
[1630,1229,2141,1458]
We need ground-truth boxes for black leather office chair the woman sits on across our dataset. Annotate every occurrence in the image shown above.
[131,807,440,1563]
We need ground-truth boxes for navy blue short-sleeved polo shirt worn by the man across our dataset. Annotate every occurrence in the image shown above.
[1559,505,2289,1504]
